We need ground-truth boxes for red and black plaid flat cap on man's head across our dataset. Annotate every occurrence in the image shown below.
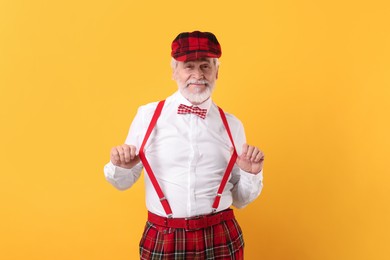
[171,31,222,61]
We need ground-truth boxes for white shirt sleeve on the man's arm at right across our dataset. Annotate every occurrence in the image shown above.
[230,119,263,208]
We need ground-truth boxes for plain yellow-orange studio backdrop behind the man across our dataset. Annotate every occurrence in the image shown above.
[0,0,390,260]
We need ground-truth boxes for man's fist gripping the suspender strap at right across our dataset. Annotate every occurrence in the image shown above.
[236,144,264,174]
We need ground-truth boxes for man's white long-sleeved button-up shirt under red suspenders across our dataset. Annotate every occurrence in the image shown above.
[104,92,263,218]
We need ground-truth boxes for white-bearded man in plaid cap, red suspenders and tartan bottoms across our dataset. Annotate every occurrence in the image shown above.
[104,31,264,259]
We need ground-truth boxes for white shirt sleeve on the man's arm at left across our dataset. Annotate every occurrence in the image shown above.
[104,107,145,190]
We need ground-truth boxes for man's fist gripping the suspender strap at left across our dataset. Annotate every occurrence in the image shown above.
[111,144,140,169]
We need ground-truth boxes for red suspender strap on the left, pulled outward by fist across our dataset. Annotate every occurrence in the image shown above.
[139,100,172,218]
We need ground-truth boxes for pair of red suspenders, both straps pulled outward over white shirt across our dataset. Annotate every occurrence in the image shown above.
[139,100,237,218]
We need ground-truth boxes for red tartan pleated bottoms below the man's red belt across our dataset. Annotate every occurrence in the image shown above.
[140,215,244,260]
